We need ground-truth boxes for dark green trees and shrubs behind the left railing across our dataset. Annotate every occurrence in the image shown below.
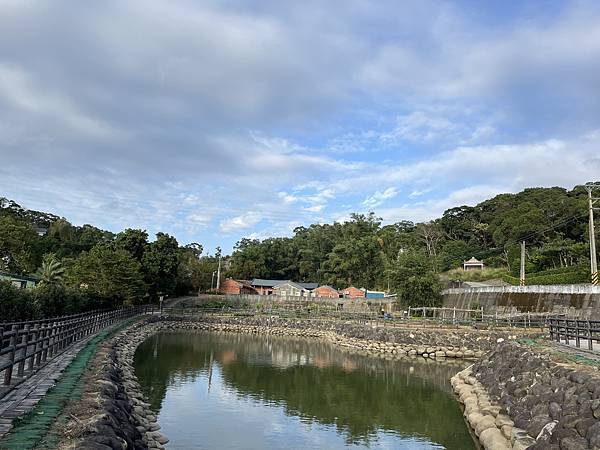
[0,198,217,320]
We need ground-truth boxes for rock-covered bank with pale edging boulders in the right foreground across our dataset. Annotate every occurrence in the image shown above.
[452,343,600,450]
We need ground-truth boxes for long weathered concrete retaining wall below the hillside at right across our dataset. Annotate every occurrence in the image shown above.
[442,285,600,320]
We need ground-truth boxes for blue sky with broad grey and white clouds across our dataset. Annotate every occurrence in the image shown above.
[0,0,600,253]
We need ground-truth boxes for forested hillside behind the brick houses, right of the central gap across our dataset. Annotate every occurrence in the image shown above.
[231,187,589,301]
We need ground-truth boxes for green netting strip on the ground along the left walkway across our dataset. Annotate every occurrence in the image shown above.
[0,319,136,450]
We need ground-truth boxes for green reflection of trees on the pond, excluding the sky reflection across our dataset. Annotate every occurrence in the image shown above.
[135,332,474,449]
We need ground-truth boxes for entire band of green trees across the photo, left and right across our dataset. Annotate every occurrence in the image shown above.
[0,187,589,318]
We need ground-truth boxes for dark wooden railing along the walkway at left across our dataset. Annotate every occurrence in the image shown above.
[0,305,154,387]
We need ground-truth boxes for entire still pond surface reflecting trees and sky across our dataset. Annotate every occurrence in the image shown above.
[135,332,475,450]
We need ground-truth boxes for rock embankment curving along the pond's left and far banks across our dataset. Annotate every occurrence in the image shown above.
[55,317,544,450]
